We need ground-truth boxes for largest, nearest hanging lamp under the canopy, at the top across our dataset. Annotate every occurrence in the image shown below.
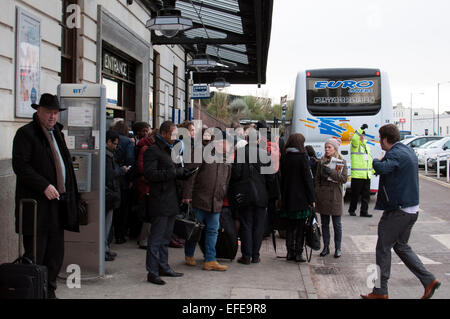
[145,8,193,38]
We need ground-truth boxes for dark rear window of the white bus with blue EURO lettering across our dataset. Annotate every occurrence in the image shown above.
[306,77,381,115]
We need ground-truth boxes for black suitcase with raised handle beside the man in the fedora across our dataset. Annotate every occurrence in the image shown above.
[0,199,48,299]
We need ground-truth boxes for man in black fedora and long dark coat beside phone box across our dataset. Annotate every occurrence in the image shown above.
[12,93,79,298]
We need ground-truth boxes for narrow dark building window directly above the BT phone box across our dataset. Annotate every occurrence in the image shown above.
[60,0,78,83]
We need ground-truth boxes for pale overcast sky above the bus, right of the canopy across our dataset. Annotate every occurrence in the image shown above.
[224,0,450,113]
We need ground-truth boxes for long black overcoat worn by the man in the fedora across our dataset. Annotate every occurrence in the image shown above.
[12,113,79,235]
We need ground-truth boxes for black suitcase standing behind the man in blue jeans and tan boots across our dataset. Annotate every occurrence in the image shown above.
[199,207,239,260]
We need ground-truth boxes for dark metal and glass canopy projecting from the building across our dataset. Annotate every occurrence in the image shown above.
[142,0,273,84]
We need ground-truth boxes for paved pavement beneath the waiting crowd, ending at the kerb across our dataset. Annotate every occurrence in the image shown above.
[57,238,315,299]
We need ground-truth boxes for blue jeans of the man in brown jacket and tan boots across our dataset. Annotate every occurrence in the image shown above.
[184,208,220,262]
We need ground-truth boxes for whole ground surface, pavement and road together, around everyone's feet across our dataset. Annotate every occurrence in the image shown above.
[57,172,450,299]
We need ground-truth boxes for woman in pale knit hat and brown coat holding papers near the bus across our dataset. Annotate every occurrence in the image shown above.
[314,138,348,258]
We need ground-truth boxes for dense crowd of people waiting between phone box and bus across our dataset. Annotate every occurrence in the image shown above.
[105,121,347,284]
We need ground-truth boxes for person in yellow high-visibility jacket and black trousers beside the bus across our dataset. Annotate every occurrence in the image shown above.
[348,124,372,217]
